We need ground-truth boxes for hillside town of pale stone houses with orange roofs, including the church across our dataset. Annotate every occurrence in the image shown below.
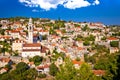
[0,18,120,79]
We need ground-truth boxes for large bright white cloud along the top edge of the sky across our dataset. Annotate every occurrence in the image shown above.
[19,0,100,11]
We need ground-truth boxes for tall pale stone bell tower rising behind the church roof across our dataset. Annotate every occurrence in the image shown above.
[28,18,33,43]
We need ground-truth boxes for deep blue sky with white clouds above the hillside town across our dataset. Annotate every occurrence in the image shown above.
[0,0,120,25]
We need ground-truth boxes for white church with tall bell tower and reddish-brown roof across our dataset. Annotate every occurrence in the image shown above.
[22,18,48,57]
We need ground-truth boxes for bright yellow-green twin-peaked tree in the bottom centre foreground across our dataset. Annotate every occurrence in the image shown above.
[55,59,99,80]
